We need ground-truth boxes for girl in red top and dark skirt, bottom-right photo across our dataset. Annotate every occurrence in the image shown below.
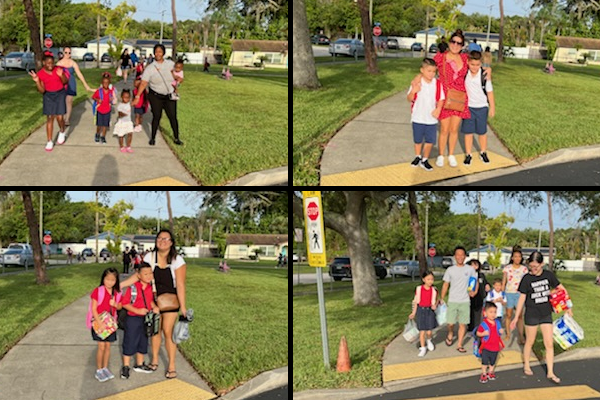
[408,271,438,357]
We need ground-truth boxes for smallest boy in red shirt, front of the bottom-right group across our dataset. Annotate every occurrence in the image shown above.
[473,302,504,383]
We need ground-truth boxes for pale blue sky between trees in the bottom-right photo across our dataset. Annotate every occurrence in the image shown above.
[451,192,584,230]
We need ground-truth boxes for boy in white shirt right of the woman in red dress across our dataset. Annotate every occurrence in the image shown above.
[461,51,496,166]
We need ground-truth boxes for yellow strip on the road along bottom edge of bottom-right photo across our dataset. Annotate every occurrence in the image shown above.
[410,385,600,400]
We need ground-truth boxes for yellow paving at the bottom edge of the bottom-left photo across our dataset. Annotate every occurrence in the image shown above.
[98,379,217,400]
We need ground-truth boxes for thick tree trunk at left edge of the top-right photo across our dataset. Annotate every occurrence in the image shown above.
[293,0,321,89]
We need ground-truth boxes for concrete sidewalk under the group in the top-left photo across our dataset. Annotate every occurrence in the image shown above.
[0,81,199,186]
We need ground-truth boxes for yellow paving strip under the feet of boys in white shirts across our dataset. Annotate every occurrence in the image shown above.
[321,151,518,186]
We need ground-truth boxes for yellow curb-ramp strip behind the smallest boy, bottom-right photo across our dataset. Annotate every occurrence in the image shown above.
[383,350,535,382]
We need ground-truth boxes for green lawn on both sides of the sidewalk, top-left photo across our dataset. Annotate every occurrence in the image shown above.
[0,69,288,185]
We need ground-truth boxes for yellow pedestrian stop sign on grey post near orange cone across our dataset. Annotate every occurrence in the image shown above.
[302,192,330,369]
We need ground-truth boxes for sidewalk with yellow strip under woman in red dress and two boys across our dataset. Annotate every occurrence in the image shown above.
[321,92,518,186]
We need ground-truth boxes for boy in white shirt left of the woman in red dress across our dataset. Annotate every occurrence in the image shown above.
[406,58,446,171]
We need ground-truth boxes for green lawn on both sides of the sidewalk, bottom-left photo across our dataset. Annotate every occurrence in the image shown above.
[0,259,288,392]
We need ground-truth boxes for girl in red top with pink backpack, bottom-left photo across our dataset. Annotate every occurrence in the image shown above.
[86,268,121,382]
